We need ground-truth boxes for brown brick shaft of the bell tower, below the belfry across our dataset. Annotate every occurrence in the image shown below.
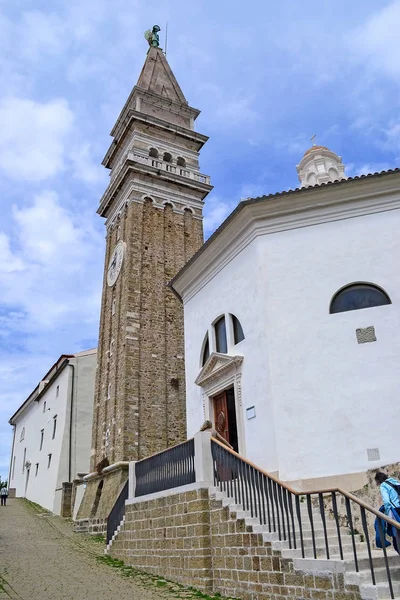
[92,199,202,469]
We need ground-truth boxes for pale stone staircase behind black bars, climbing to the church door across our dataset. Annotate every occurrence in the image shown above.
[210,488,400,600]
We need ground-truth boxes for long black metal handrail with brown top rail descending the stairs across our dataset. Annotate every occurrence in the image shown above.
[211,438,400,599]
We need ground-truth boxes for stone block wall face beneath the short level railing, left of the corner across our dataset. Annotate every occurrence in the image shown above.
[107,489,212,591]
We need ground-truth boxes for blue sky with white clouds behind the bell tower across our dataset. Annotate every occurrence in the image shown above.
[0,0,400,476]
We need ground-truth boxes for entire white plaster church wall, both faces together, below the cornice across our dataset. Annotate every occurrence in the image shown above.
[185,199,400,481]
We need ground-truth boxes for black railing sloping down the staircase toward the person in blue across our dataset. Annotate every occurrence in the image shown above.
[211,439,400,598]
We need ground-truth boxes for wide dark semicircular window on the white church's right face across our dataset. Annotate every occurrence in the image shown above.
[329,283,392,314]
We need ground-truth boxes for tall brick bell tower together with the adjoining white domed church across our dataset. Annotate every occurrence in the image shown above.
[73,30,400,526]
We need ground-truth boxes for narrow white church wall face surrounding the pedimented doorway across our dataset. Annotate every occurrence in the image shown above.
[185,243,277,471]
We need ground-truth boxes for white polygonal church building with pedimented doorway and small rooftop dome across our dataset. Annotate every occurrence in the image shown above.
[171,146,400,489]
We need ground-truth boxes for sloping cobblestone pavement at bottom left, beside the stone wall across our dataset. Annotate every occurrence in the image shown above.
[0,500,216,600]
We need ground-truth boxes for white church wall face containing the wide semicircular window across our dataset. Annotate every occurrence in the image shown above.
[257,211,400,480]
